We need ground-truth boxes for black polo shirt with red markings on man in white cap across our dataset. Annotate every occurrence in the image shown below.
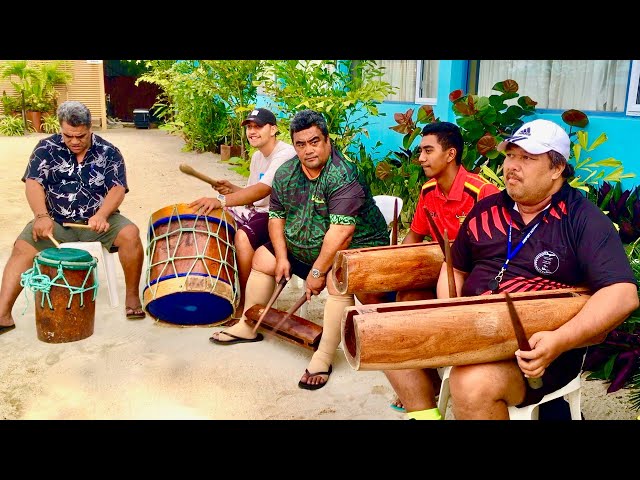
[451,183,636,296]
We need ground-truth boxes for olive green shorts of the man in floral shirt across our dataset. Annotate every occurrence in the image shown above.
[18,213,133,251]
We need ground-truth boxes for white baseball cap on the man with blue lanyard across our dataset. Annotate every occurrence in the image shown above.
[498,118,571,160]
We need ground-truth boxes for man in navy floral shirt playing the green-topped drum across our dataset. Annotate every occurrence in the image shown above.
[0,101,145,333]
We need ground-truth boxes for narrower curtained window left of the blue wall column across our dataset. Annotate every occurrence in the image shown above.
[376,60,439,105]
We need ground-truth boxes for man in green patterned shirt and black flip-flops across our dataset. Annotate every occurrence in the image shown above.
[211,110,389,390]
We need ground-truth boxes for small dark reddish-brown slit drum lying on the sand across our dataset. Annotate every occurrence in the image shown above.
[244,305,322,351]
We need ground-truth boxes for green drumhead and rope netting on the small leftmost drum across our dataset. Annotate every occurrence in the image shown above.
[20,248,98,309]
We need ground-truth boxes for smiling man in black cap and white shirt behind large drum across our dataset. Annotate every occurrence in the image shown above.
[189,108,296,323]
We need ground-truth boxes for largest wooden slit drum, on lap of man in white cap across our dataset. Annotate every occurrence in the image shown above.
[341,288,590,370]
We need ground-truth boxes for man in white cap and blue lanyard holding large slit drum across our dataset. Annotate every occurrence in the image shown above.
[400,119,639,419]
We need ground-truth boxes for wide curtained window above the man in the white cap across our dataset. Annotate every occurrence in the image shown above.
[478,60,640,115]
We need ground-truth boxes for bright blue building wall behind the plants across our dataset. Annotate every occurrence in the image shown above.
[262,60,640,188]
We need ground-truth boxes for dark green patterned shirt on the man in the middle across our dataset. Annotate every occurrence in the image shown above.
[269,147,389,265]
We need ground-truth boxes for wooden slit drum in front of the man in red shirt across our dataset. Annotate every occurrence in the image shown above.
[331,242,444,295]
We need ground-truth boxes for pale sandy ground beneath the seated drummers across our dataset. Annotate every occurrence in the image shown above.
[0,128,639,420]
